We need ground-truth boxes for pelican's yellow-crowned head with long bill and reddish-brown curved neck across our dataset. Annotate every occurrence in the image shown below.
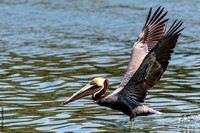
[63,77,109,105]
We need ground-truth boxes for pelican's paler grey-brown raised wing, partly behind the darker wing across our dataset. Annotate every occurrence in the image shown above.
[120,7,168,88]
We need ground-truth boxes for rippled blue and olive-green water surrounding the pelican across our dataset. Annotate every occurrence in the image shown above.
[0,0,200,133]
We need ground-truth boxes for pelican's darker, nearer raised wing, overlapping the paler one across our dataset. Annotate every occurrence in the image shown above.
[117,20,184,102]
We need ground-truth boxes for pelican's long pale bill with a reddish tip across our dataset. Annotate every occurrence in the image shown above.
[63,84,98,105]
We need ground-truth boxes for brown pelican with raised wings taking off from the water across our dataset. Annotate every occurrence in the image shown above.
[63,7,184,121]
